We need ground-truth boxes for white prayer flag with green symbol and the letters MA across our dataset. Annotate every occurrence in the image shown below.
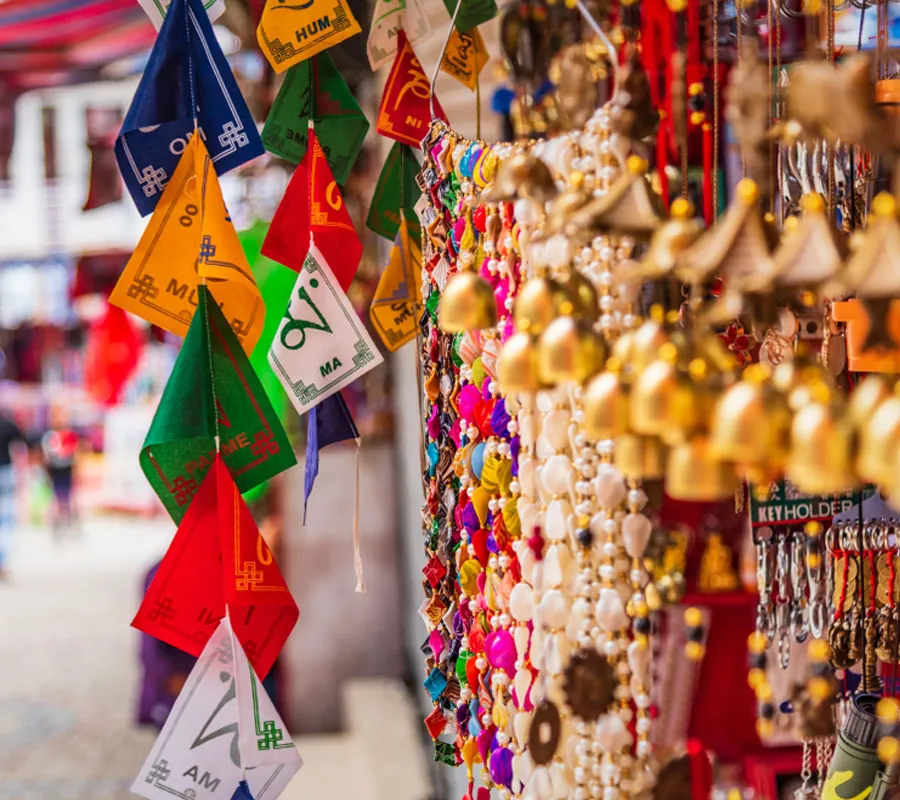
[269,243,383,416]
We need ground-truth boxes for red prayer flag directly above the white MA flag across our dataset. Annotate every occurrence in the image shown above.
[262,131,362,292]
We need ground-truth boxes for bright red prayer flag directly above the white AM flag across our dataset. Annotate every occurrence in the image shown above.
[131,456,299,680]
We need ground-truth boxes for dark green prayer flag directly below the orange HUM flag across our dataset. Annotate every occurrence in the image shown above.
[262,53,369,183]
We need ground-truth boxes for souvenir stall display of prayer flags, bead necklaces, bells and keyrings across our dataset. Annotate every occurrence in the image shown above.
[79,0,900,800]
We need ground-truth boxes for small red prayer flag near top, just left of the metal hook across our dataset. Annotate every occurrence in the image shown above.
[377,28,447,147]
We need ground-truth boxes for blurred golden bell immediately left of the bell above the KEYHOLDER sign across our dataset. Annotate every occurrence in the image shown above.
[710,365,791,477]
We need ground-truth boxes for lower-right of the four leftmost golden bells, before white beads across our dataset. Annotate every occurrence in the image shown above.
[537,317,606,386]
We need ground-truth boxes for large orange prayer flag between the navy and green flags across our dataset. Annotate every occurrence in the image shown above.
[109,136,266,352]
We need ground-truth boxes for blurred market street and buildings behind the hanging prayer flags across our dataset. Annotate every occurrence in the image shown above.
[0,0,502,800]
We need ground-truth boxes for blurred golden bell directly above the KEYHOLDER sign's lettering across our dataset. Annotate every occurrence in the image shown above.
[785,398,857,494]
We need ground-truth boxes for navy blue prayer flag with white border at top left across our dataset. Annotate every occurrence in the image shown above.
[115,0,264,216]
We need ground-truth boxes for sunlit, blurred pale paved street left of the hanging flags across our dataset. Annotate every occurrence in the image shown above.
[0,517,172,800]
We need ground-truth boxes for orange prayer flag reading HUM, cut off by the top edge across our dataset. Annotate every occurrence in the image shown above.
[256,0,360,72]
